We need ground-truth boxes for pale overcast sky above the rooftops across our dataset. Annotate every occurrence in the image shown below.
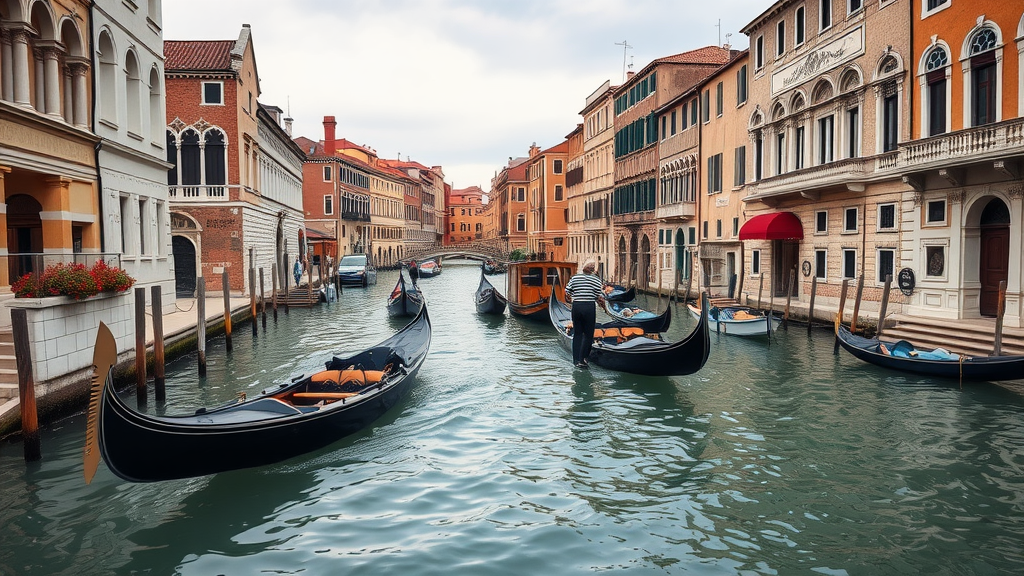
[157,0,753,192]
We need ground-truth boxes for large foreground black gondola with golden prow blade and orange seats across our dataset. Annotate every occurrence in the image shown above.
[84,305,430,482]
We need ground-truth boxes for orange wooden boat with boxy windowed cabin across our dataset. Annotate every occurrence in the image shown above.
[505,260,577,321]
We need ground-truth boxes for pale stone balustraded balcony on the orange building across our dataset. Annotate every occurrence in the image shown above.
[897,118,1024,174]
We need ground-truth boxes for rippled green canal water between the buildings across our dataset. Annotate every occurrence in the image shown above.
[0,262,1024,576]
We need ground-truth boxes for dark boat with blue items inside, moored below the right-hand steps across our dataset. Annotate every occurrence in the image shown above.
[836,325,1024,380]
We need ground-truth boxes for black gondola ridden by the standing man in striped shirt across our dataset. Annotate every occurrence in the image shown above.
[548,286,711,376]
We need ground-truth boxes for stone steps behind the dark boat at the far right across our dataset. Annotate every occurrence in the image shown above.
[883,316,1024,356]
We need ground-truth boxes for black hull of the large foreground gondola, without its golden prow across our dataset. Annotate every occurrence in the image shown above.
[98,306,430,482]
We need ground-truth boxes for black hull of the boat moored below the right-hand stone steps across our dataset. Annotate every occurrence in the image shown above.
[837,326,1024,381]
